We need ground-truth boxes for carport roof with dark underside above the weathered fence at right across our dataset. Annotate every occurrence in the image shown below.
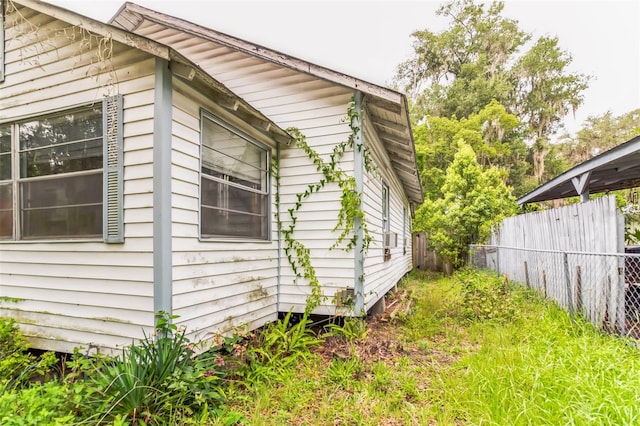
[518,135,640,205]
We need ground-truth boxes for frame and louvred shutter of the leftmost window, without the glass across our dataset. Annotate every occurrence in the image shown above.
[0,95,124,244]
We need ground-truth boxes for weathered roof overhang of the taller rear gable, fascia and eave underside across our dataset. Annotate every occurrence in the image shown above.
[110,2,423,204]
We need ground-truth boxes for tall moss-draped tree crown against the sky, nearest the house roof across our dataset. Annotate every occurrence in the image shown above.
[396,0,530,118]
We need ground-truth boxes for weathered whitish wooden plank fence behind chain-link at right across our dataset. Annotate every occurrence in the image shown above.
[470,196,640,334]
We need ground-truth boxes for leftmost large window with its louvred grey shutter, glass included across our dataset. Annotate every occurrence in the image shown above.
[0,97,122,241]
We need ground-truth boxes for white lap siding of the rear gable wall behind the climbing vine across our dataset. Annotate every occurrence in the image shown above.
[136,22,362,314]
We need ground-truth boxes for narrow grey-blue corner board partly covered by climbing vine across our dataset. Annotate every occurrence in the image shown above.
[353,91,366,316]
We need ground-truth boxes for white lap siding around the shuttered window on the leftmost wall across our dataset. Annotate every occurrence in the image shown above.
[0,9,154,352]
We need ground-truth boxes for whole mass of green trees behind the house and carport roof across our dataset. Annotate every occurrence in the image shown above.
[395,0,640,267]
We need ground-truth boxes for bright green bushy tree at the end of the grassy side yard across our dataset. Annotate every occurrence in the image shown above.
[414,140,517,267]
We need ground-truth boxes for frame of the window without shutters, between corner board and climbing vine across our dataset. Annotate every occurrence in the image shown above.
[198,108,273,243]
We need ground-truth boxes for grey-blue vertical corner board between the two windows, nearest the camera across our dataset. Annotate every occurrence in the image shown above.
[153,58,173,322]
